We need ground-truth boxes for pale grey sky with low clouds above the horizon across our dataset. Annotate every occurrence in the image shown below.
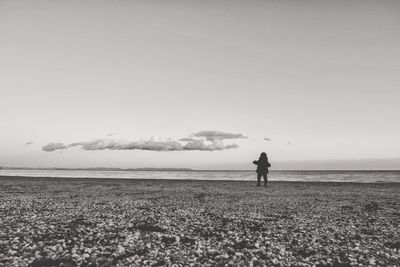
[0,0,400,169]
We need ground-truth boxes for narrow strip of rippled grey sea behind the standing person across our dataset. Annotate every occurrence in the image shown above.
[0,169,400,183]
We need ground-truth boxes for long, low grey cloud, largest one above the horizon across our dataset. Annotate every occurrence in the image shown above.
[42,131,246,152]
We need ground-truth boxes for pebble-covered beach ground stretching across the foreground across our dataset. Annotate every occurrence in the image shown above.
[0,177,400,266]
